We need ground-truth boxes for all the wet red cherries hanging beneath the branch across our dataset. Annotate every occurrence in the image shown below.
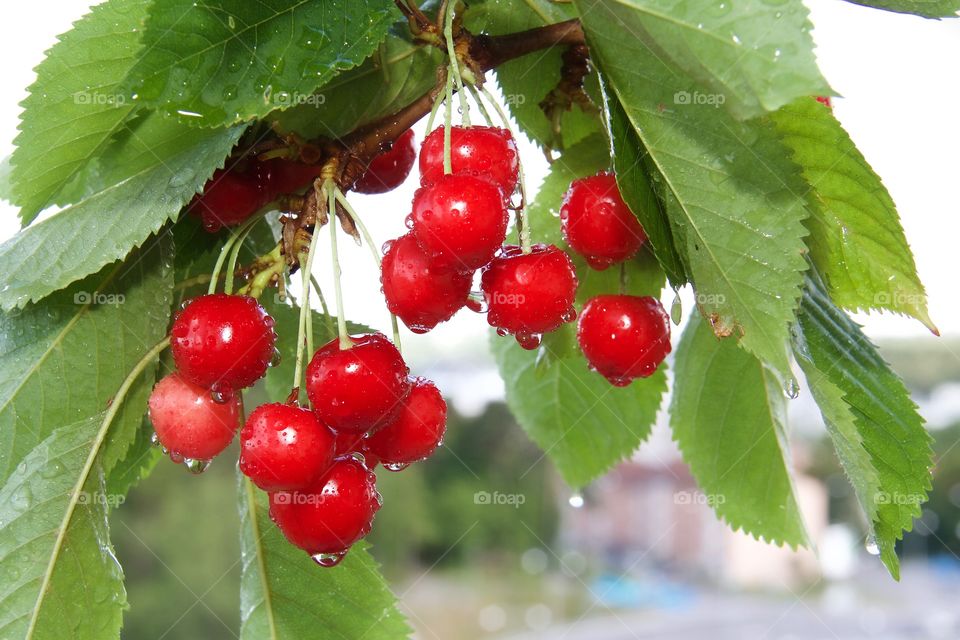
[149,120,670,566]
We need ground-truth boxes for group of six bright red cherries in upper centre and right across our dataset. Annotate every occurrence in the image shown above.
[381,126,670,386]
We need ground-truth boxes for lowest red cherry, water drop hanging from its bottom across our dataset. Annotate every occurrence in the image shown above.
[270,456,380,555]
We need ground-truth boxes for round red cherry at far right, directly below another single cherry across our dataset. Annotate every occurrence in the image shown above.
[577,295,670,387]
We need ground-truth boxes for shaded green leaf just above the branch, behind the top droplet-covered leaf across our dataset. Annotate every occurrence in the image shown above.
[266,24,444,139]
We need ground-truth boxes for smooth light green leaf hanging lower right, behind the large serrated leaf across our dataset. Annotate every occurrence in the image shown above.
[670,314,809,547]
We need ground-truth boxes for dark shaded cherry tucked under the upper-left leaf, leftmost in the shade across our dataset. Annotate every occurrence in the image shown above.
[188,168,269,233]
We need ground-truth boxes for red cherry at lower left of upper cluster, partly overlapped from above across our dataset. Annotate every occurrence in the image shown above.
[380,233,473,333]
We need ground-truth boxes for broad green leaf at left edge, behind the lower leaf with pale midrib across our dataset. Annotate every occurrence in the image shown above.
[0,241,173,482]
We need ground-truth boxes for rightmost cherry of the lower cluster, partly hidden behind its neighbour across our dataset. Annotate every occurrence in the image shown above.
[364,378,447,471]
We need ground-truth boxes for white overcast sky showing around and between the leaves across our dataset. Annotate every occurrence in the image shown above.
[0,0,960,364]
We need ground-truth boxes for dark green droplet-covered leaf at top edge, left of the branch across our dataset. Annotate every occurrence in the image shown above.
[130,0,399,127]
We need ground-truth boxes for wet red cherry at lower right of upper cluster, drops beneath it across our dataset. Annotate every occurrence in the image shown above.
[480,244,577,349]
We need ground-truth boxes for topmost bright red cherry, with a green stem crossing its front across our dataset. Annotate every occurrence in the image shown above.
[420,126,520,197]
